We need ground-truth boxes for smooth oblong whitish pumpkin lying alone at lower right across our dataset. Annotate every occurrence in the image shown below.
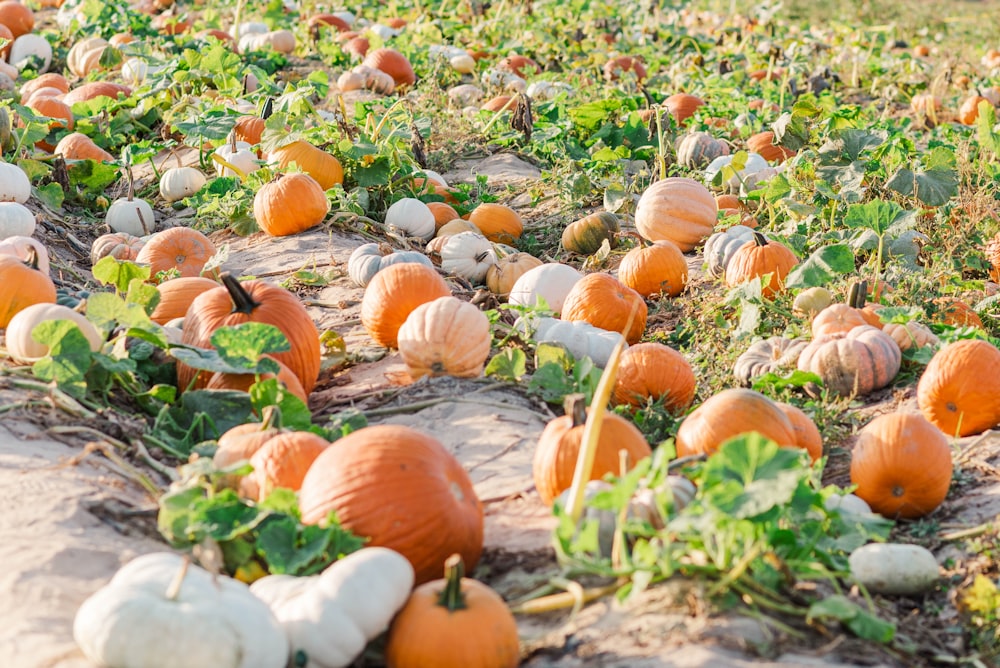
[847,543,940,596]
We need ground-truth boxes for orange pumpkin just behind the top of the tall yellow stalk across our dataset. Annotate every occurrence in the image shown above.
[561,272,648,344]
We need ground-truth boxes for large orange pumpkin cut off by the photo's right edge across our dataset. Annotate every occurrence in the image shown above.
[917,339,1000,436]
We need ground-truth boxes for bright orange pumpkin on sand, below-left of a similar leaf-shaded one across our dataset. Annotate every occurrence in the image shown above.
[253,174,330,237]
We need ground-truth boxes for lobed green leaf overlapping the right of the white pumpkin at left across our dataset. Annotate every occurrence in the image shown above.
[31,320,93,399]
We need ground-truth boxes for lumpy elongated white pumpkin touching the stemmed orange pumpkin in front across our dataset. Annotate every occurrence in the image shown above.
[250,547,414,668]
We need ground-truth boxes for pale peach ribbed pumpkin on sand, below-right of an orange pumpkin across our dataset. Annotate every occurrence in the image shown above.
[397,296,491,378]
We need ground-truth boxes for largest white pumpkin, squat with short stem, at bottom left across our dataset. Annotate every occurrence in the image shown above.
[73,552,288,668]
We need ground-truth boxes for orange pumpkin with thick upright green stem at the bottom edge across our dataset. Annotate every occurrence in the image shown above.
[385,554,520,668]
